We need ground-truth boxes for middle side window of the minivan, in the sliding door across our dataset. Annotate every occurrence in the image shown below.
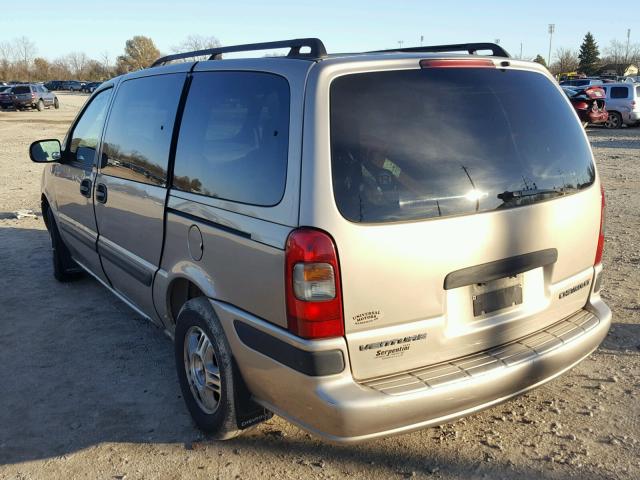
[101,74,186,186]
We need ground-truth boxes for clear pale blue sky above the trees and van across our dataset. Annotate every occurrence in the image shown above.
[0,0,640,61]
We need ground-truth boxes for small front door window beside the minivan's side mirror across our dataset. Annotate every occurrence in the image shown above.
[67,89,112,168]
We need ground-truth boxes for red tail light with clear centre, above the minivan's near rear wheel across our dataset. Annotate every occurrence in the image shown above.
[285,228,344,339]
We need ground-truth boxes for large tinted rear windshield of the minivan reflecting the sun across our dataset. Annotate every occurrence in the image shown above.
[331,68,595,222]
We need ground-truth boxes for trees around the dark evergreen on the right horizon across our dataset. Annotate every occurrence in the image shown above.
[534,32,640,76]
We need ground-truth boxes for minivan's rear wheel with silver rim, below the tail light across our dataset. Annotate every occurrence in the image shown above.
[174,297,254,440]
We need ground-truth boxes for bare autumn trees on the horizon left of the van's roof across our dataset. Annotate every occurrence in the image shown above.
[0,35,220,82]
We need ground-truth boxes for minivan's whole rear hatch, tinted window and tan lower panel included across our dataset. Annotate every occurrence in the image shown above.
[326,61,601,379]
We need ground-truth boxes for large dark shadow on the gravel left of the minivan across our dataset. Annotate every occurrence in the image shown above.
[0,225,195,464]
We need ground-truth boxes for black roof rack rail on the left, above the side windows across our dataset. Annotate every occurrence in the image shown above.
[151,38,327,67]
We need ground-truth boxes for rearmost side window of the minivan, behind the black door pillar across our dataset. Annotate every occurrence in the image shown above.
[173,72,289,206]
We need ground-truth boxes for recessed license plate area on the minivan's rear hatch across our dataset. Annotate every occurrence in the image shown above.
[471,274,522,317]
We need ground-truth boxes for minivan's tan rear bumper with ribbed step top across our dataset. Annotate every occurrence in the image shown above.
[212,296,611,443]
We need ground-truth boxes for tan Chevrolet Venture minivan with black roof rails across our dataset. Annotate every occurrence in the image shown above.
[30,39,611,442]
